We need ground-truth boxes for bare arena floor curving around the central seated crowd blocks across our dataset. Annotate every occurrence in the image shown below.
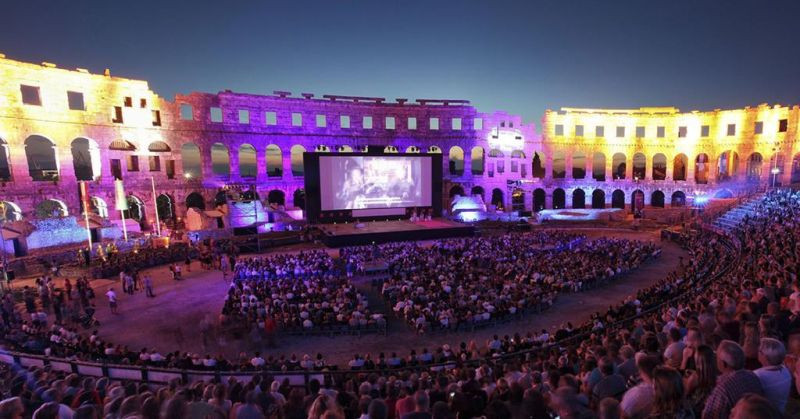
[39,230,686,364]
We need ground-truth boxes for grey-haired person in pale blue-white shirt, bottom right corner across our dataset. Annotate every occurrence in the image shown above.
[753,338,792,413]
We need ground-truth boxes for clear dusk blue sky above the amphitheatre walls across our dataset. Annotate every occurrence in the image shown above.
[0,0,800,124]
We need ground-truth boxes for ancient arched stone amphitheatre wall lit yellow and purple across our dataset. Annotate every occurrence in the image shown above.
[0,56,800,248]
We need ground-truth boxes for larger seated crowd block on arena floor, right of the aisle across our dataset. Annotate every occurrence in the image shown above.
[381,232,660,333]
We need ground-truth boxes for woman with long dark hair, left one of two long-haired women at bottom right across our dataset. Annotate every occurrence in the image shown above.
[649,366,695,419]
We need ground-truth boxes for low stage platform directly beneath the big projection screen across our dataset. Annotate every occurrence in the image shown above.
[318,218,475,247]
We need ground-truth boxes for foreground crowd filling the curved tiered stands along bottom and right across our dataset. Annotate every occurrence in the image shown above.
[0,190,800,419]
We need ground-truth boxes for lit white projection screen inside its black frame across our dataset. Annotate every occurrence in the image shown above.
[319,156,432,211]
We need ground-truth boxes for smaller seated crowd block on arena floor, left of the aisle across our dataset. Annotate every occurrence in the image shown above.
[221,250,385,333]
